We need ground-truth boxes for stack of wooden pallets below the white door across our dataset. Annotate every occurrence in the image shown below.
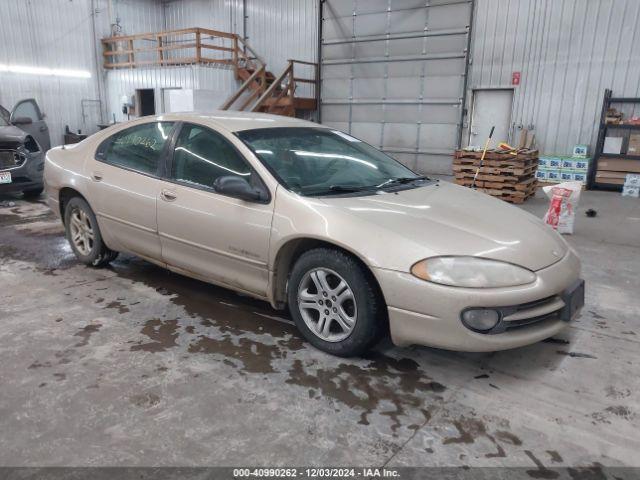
[453,149,538,203]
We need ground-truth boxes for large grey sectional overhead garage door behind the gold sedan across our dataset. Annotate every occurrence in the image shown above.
[321,0,473,174]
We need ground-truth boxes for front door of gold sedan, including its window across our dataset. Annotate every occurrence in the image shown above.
[157,123,273,296]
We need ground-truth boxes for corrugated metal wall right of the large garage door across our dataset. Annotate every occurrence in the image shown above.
[465,0,640,154]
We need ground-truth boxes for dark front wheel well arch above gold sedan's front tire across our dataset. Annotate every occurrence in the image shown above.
[273,238,386,314]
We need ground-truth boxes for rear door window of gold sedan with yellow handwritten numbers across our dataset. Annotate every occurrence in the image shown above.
[98,122,173,175]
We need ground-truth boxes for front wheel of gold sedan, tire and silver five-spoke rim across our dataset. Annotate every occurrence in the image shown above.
[287,248,386,357]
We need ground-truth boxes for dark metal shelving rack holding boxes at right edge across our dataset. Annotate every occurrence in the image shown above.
[587,89,640,190]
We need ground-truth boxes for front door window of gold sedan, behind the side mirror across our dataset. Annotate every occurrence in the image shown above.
[171,124,251,188]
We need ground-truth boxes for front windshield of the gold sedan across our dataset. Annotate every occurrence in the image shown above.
[236,127,427,196]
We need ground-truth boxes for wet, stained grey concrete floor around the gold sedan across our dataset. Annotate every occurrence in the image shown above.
[0,192,640,466]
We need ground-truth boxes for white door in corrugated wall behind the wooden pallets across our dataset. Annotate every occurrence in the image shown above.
[469,89,513,148]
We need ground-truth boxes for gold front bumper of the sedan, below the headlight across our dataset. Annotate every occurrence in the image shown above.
[373,250,580,352]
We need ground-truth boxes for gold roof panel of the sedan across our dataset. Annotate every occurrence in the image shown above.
[146,110,323,132]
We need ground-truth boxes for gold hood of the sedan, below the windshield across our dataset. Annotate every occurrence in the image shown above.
[324,182,568,271]
